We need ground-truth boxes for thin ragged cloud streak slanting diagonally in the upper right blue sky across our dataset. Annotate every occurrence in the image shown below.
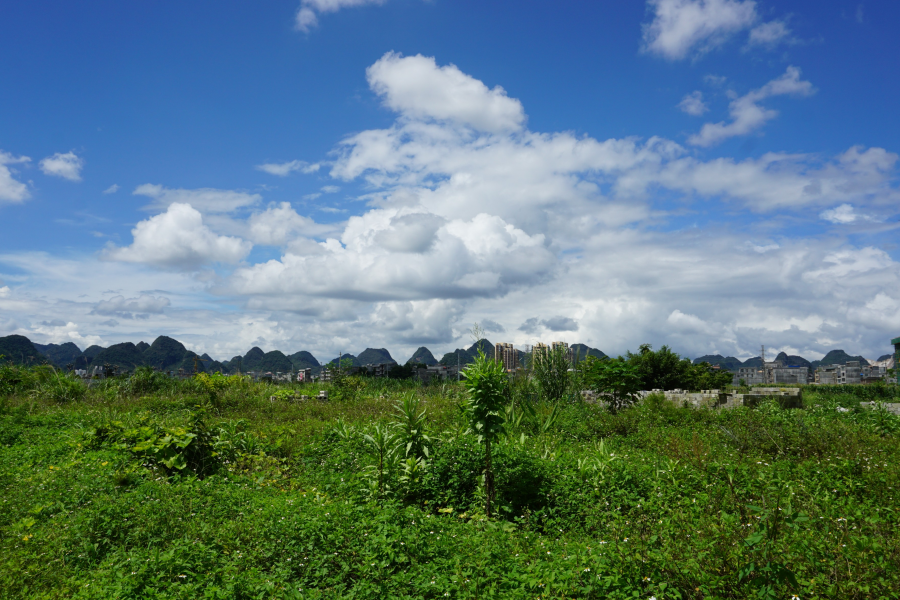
[688,67,815,147]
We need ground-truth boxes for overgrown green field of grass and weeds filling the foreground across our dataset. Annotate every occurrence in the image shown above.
[0,367,900,600]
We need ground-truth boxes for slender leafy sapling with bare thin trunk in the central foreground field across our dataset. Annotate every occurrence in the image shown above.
[462,349,509,518]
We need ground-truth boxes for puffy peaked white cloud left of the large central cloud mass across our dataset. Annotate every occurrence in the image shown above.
[106,202,252,270]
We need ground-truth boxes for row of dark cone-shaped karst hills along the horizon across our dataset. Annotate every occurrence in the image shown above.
[0,335,891,373]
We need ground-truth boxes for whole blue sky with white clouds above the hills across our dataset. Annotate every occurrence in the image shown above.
[0,0,900,360]
